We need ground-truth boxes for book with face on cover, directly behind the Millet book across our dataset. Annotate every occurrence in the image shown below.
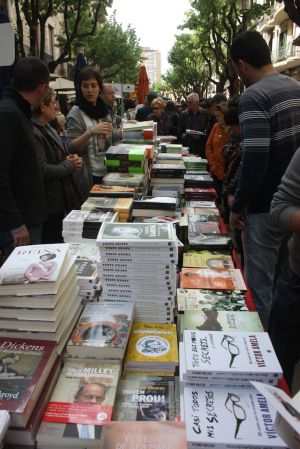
[66,303,134,359]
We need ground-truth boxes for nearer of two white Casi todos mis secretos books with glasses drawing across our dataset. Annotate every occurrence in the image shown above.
[184,387,286,449]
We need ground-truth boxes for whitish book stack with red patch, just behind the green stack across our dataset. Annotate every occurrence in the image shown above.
[122,120,157,144]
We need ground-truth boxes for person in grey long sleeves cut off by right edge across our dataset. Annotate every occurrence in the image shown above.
[269,149,300,388]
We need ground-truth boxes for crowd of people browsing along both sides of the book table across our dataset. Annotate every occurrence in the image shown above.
[0,31,300,386]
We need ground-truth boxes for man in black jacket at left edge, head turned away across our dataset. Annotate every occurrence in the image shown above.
[0,57,50,256]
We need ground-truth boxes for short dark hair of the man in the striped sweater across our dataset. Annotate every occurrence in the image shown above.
[230,31,272,69]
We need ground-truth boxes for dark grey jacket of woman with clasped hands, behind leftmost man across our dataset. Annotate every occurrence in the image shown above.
[33,120,74,214]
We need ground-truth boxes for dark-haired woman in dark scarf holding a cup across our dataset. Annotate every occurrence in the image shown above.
[66,67,112,199]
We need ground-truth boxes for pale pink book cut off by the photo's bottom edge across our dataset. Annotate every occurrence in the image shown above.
[103,421,188,449]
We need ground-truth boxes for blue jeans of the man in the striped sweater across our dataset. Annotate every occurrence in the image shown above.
[242,213,287,327]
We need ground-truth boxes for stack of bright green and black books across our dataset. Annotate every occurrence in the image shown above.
[105,143,152,173]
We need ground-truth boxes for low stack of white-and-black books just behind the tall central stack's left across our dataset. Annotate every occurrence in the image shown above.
[62,209,119,243]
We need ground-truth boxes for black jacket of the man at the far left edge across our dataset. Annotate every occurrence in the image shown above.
[0,89,47,231]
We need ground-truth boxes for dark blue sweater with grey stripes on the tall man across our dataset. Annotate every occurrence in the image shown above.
[232,73,300,213]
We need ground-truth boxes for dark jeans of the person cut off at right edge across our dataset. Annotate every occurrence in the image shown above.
[269,263,300,388]
